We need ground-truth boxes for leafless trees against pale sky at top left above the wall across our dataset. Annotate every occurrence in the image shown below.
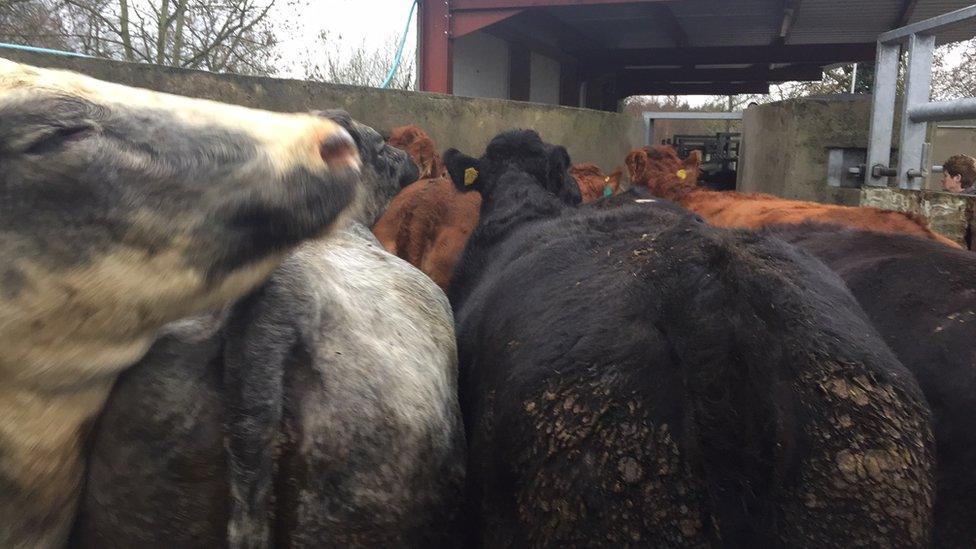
[0,0,286,74]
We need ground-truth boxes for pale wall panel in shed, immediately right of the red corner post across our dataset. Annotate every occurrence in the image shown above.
[454,32,509,99]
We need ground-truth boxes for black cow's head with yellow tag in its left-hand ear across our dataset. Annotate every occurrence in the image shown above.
[444,130,582,205]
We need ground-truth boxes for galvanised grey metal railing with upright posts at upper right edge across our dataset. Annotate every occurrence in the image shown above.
[864,4,976,190]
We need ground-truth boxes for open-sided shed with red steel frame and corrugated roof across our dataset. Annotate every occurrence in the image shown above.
[419,0,972,110]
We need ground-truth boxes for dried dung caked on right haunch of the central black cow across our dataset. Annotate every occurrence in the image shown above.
[783,363,934,547]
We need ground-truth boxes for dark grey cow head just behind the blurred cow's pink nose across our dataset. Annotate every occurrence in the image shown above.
[316,109,419,227]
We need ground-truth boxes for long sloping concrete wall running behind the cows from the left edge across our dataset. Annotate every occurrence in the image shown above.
[0,51,642,171]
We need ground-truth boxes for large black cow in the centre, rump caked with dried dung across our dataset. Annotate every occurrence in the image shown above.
[445,127,934,547]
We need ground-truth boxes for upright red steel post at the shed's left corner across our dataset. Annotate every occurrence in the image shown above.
[418,0,454,93]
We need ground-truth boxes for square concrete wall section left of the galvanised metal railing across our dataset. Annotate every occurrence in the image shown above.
[738,95,871,206]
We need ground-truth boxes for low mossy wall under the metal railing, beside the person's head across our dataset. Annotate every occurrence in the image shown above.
[860,187,976,250]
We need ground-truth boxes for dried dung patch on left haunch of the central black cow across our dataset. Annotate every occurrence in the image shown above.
[518,372,713,547]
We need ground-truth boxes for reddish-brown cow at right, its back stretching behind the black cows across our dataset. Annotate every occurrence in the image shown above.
[626,145,961,248]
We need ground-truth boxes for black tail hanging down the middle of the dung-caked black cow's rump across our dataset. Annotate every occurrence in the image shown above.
[659,226,794,547]
